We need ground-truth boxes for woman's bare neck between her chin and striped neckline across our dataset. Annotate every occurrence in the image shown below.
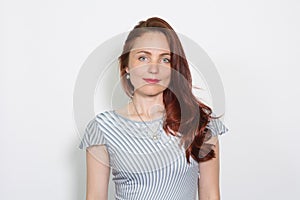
[129,94,165,120]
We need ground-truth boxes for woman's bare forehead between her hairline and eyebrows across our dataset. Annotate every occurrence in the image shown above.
[132,32,170,51]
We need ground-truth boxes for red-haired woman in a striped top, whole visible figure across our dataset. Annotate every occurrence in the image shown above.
[79,17,228,200]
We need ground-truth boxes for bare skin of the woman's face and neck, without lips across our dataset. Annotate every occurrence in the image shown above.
[119,32,171,121]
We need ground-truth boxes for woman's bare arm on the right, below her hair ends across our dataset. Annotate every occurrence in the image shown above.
[198,141,220,200]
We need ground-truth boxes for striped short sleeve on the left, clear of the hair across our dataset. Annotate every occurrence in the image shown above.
[78,117,106,149]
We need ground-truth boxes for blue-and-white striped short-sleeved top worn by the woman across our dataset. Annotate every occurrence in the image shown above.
[79,110,228,200]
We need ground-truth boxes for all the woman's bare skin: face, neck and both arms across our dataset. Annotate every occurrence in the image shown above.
[86,32,220,200]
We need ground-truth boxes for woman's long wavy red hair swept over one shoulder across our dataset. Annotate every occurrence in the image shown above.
[119,17,218,163]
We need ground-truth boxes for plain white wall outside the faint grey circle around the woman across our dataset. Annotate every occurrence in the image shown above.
[0,0,300,200]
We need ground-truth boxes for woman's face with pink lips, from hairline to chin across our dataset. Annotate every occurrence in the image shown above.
[126,32,171,96]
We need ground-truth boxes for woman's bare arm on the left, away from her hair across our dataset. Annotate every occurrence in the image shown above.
[86,145,110,200]
